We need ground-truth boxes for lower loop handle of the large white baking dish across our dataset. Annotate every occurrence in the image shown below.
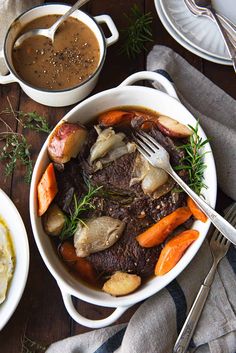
[61,289,130,328]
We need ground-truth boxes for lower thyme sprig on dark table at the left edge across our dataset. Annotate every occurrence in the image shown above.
[0,119,33,184]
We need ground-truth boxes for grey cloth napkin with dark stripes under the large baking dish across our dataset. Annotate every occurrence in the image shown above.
[46,46,236,353]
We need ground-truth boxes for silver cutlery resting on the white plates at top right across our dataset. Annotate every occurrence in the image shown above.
[184,0,236,72]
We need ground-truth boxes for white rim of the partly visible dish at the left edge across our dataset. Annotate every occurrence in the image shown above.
[0,189,29,331]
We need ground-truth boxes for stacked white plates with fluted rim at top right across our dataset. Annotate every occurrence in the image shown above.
[154,0,236,65]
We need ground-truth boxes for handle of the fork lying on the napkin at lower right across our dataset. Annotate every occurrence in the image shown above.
[173,284,210,353]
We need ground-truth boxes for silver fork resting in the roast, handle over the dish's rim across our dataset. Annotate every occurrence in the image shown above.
[134,131,236,244]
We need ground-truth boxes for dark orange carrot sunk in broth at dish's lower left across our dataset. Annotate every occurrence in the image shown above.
[60,241,97,284]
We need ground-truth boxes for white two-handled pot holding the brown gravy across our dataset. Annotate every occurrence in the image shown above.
[0,4,119,107]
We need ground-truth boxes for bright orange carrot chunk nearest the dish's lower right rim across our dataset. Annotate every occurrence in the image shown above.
[155,229,199,276]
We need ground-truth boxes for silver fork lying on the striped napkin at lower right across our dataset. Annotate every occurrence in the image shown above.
[173,203,236,353]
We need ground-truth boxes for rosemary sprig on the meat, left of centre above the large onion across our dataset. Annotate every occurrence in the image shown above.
[60,184,102,240]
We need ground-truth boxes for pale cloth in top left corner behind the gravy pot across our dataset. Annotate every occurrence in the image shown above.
[0,0,43,75]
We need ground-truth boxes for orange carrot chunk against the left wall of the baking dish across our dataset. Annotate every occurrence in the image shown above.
[38,163,58,216]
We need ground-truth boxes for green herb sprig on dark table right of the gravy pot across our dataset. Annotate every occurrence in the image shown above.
[121,4,152,59]
